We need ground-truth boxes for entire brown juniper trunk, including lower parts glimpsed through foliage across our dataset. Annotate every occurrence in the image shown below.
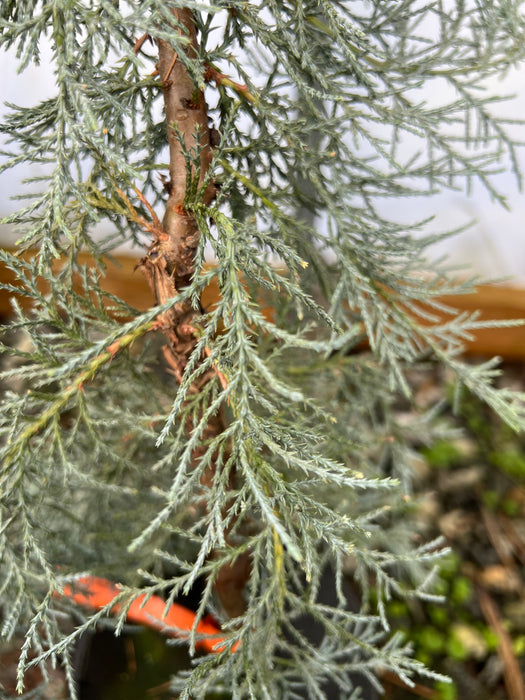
[141,9,249,617]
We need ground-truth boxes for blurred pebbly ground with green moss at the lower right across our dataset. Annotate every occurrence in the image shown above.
[384,358,525,700]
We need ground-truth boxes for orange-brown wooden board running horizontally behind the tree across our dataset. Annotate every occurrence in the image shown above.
[0,249,525,361]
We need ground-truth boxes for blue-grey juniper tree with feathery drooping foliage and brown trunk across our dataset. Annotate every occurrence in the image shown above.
[0,0,525,699]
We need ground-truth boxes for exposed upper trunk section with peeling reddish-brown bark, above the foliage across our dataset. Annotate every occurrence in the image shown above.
[141,9,214,380]
